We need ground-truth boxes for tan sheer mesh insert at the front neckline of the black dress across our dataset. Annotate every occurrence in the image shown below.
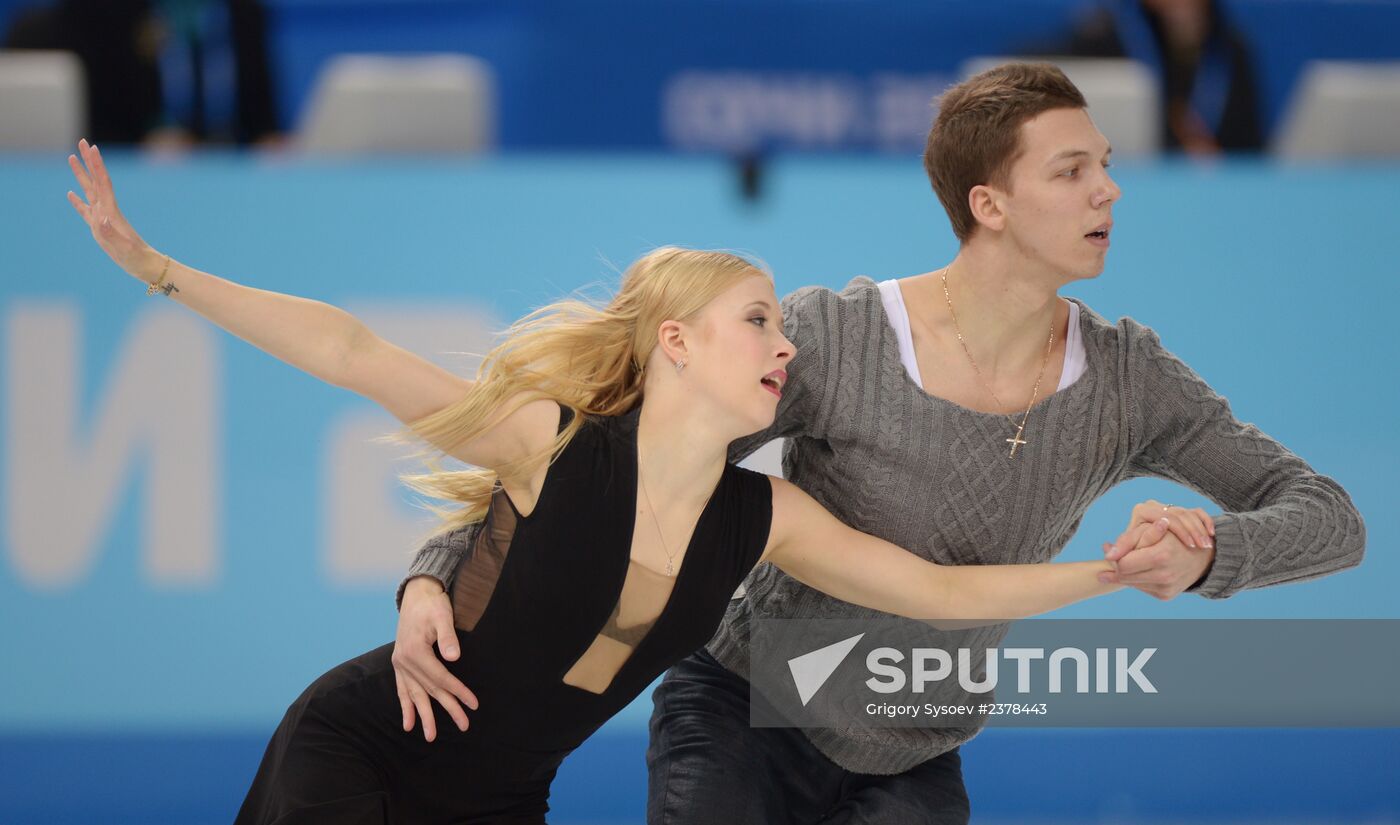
[564,562,676,693]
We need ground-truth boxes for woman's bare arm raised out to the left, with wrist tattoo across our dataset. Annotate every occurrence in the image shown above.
[69,140,559,468]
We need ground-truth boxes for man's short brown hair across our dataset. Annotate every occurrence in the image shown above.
[924,63,1088,244]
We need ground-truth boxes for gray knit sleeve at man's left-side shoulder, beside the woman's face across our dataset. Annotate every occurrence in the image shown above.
[729,287,841,462]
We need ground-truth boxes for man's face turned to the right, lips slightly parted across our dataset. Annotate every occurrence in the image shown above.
[1001,109,1123,279]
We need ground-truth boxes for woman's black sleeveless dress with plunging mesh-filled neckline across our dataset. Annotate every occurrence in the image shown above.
[237,410,773,825]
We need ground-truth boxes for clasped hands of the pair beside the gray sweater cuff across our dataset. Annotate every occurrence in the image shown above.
[1099,501,1215,601]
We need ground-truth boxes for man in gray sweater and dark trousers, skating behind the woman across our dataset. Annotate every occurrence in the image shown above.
[395,64,1365,825]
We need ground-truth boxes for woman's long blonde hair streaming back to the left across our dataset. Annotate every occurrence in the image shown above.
[400,247,769,534]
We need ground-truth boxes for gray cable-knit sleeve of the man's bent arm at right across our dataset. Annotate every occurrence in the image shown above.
[1119,319,1366,598]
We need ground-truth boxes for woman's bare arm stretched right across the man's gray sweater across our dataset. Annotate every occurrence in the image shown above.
[763,479,1168,623]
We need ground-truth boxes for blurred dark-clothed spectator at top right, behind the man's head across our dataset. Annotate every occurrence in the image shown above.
[1056,0,1264,154]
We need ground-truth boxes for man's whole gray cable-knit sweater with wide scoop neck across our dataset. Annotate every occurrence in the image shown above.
[400,277,1365,773]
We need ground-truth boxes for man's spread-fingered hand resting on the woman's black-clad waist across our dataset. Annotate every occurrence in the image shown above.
[392,576,479,742]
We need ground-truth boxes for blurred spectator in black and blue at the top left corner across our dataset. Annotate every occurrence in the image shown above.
[4,0,277,146]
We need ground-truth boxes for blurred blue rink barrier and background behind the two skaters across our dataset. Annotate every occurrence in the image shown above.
[0,0,1400,824]
